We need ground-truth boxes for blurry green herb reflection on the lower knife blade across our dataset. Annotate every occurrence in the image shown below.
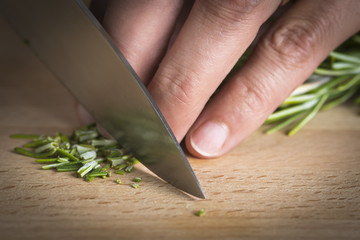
[103,111,204,198]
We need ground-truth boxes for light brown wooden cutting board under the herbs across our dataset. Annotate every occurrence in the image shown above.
[0,17,360,239]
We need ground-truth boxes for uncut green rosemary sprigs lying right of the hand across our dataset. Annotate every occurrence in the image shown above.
[265,35,360,136]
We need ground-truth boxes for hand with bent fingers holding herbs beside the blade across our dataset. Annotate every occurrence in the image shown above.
[100,0,360,158]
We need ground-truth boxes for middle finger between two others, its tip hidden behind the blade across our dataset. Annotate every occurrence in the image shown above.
[148,0,280,141]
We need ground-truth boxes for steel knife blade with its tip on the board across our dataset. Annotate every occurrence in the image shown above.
[0,0,205,198]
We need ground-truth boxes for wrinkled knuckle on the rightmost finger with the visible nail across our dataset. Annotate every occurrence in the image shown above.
[263,19,322,65]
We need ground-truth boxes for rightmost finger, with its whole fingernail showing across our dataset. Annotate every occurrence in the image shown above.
[186,0,360,158]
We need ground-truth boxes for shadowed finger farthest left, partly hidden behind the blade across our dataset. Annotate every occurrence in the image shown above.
[103,0,182,84]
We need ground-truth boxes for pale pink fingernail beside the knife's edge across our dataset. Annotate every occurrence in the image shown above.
[190,121,229,157]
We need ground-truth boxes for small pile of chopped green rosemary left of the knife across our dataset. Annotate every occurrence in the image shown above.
[11,124,141,182]
